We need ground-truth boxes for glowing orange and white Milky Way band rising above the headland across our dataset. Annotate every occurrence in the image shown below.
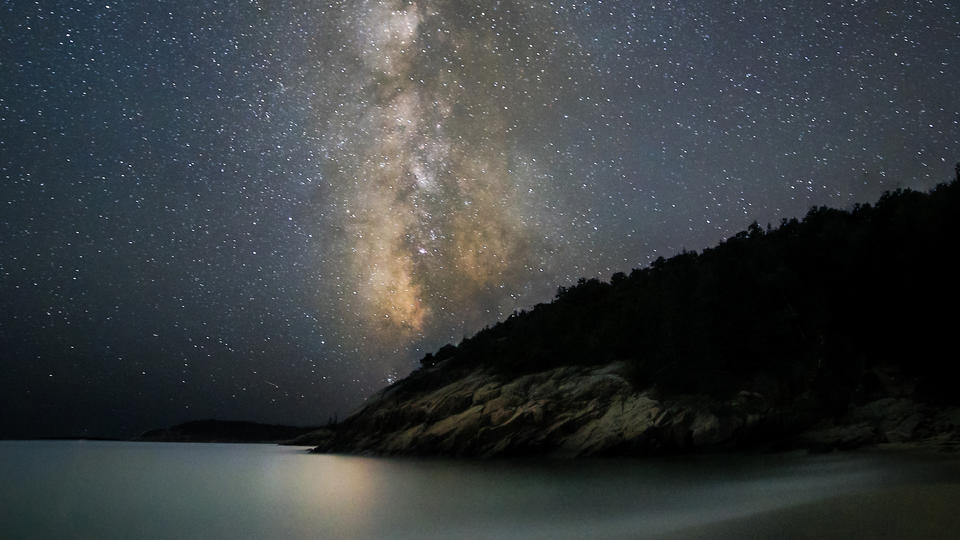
[326,2,555,356]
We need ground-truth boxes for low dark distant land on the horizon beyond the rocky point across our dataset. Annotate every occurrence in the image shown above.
[134,420,317,443]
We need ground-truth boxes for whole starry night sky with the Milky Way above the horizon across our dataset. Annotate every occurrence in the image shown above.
[0,0,960,436]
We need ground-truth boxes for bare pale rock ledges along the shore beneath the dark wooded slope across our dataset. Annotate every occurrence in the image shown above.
[310,363,960,457]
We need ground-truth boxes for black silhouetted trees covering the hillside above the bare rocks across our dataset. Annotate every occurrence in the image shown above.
[424,168,960,410]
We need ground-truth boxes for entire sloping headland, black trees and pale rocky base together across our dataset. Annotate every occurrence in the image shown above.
[299,165,960,457]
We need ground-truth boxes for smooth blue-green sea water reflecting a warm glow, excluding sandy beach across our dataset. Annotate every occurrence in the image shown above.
[0,441,960,539]
